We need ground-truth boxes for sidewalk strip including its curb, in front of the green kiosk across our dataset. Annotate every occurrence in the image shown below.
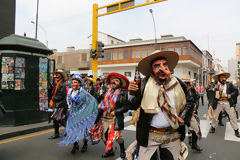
[0,121,53,140]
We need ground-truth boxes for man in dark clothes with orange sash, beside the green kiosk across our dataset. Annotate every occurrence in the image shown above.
[49,69,67,139]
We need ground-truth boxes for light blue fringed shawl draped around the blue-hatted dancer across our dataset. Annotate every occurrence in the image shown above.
[59,89,98,146]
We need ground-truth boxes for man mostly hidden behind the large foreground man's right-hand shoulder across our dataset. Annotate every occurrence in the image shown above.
[182,75,202,152]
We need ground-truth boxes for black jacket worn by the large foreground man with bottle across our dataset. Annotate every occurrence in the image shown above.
[130,77,194,147]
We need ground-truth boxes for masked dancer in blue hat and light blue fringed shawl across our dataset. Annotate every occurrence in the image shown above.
[59,74,98,154]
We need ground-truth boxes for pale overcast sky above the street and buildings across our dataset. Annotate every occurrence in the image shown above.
[16,0,240,66]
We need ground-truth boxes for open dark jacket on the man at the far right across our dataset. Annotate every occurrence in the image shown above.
[209,82,238,109]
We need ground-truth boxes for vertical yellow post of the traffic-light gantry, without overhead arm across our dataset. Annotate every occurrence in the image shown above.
[92,3,98,82]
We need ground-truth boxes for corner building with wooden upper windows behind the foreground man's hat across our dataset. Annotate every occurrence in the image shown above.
[98,35,203,80]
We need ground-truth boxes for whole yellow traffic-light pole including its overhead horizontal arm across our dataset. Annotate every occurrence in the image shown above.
[92,0,166,82]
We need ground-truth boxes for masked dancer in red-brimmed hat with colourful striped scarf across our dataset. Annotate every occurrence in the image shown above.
[95,73,130,159]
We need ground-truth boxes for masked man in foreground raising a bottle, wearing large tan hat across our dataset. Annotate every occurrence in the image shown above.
[128,50,193,160]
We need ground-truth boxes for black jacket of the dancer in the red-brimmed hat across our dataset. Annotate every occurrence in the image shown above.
[95,91,131,131]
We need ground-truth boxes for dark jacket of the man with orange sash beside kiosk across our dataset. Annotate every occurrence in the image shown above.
[52,81,68,108]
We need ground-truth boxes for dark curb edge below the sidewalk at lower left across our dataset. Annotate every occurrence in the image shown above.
[0,125,53,141]
